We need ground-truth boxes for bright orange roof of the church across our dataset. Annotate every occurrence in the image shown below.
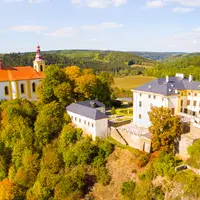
[0,66,44,81]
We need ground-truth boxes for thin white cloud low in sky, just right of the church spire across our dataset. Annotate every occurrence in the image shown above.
[45,27,79,37]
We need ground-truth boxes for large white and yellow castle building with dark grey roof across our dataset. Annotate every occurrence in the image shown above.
[132,74,200,128]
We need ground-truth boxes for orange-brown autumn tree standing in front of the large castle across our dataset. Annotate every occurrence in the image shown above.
[149,107,183,151]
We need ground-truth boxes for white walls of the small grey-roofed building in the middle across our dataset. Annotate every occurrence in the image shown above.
[67,111,108,140]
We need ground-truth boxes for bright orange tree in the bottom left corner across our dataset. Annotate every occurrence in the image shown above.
[0,179,24,200]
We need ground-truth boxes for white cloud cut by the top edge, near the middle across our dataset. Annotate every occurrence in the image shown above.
[72,0,128,8]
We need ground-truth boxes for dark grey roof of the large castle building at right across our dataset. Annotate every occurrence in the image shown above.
[133,77,200,96]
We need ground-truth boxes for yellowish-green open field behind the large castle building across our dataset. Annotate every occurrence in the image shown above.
[114,76,155,90]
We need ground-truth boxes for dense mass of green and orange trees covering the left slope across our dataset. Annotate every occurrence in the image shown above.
[0,66,114,200]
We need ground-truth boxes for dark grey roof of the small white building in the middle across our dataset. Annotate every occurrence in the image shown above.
[66,103,108,120]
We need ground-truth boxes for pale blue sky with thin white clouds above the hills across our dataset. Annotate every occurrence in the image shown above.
[0,0,200,53]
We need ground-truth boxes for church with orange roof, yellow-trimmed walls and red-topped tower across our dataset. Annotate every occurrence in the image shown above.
[0,45,46,101]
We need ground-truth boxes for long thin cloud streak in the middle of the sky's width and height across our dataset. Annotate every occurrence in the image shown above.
[81,22,123,31]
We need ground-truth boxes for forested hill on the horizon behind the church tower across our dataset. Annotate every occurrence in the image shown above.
[0,50,153,70]
